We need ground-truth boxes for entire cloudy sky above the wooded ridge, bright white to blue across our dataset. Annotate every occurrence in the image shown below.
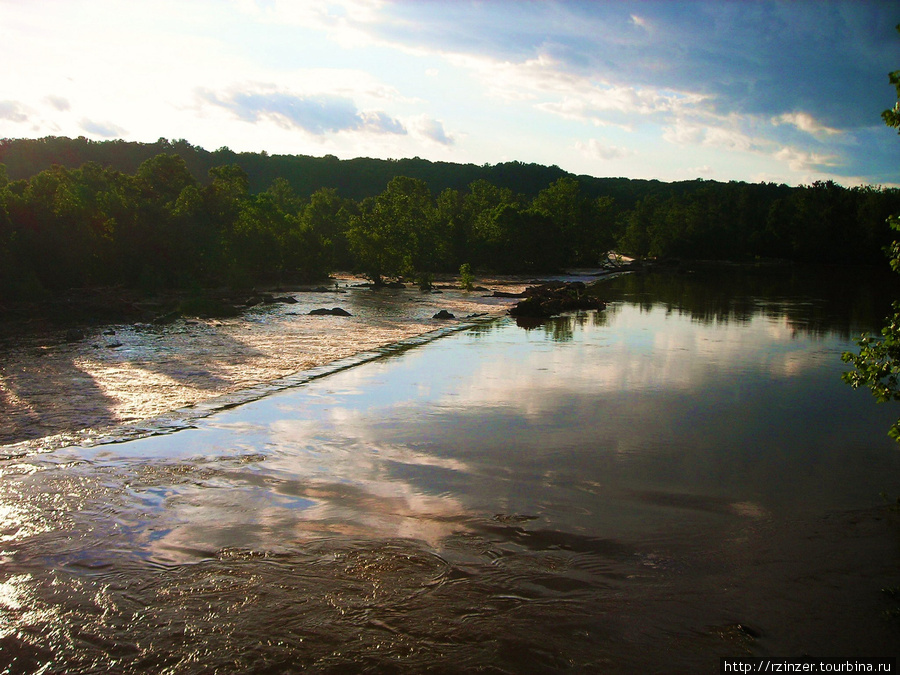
[0,0,900,186]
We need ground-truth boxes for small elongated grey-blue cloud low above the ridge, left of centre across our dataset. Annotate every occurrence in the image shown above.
[197,89,407,136]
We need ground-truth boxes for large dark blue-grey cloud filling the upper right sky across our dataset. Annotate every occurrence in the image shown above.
[342,0,900,129]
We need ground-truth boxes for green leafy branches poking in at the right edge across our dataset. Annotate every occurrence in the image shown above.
[841,25,900,442]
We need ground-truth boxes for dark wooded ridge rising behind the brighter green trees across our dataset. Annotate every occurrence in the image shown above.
[0,136,680,208]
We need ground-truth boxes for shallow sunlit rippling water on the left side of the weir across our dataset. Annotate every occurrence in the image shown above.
[0,278,509,456]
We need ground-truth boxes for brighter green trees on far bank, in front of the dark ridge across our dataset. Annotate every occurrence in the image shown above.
[0,154,614,298]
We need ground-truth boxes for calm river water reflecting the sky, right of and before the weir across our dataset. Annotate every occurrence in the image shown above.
[0,269,900,673]
